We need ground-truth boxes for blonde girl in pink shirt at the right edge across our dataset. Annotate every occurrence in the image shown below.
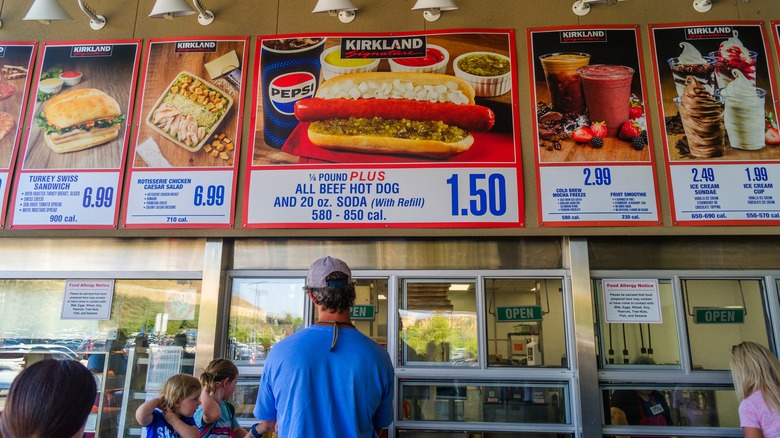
[731,341,780,438]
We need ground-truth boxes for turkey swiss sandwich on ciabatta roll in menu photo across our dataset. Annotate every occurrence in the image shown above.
[35,88,125,153]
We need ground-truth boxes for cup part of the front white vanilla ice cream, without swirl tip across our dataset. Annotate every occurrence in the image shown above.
[715,88,766,151]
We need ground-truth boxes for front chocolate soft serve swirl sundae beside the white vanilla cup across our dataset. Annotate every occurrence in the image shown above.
[675,76,724,158]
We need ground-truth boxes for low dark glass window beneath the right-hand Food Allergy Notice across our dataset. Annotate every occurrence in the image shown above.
[601,385,739,428]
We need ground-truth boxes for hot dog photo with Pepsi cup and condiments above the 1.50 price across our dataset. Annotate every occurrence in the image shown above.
[253,33,519,165]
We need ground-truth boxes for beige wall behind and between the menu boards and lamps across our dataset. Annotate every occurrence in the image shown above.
[0,0,780,237]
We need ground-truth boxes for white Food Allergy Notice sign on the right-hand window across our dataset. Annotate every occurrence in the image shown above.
[601,279,663,324]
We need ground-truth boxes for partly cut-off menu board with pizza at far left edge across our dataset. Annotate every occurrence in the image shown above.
[0,41,38,227]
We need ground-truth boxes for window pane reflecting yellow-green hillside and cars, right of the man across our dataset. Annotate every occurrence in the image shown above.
[398,280,478,366]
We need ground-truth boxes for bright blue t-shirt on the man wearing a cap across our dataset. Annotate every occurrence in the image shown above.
[254,325,393,438]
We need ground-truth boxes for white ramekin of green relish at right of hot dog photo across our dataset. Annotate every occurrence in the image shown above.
[452,52,512,97]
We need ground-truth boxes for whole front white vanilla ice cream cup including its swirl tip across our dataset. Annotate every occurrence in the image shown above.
[718,70,766,150]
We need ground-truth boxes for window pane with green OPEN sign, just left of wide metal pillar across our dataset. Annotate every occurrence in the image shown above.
[485,278,567,367]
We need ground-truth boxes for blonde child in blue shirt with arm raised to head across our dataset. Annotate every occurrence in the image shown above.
[135,374,200,438]
